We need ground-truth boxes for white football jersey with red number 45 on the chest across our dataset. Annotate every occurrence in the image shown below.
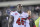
[10,11,29,27]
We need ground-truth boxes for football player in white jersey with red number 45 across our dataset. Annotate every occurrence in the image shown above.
[9,4,30,27]
